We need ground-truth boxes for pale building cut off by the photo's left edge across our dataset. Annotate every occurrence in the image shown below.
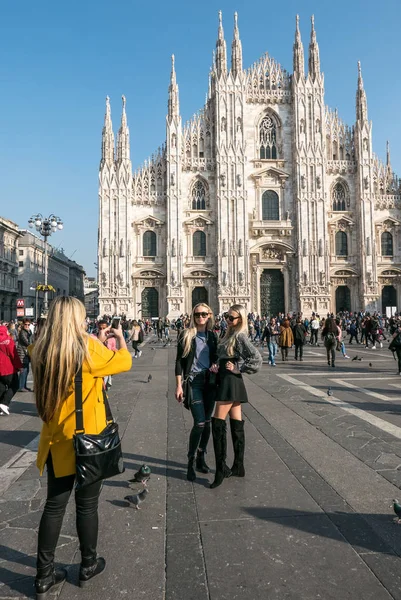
[0,217,20,321]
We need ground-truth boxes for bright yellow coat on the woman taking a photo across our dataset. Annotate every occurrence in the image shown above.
[36,337,132,477]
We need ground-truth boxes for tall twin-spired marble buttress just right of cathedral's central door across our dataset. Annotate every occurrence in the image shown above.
[293,17,330,312]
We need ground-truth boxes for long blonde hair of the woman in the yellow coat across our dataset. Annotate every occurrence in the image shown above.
[32,296,90,423]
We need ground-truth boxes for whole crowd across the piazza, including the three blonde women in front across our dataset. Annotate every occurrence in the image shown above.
[0,297,401,600]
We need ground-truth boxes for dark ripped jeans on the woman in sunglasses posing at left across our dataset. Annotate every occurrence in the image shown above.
[188,373,215,458]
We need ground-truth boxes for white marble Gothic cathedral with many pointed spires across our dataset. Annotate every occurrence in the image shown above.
[98,13,401,318]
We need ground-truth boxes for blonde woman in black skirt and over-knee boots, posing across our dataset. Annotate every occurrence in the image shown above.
[210,304,262,488]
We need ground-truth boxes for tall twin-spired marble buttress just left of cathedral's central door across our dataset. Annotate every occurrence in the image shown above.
[213,14,250,310]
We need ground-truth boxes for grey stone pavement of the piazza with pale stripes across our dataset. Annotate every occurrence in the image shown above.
[0,340,401,600]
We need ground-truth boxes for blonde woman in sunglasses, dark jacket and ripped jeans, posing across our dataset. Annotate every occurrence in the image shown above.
[175,303,217,481]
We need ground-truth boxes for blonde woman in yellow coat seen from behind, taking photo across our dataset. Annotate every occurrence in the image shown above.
[31,296,132,600]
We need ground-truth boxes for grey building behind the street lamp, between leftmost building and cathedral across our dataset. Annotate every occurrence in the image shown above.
[18,229,85,319]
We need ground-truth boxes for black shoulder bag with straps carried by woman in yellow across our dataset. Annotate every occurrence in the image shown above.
[73,367,125,490]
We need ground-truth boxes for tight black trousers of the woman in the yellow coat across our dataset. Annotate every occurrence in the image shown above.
[36,452,102,577]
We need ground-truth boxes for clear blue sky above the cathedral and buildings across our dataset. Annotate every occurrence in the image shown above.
[0,0,401,275]
